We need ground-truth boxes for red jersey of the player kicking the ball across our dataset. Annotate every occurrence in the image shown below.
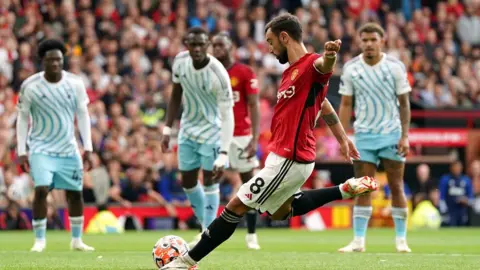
[269,53,332,163]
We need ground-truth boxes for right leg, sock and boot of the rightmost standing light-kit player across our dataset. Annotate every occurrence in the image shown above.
[382,159,411,252]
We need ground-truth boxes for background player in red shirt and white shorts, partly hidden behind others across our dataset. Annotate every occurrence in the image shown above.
[212,33,260,249]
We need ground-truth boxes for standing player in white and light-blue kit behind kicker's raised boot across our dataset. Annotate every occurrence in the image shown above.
[339,23,411,252]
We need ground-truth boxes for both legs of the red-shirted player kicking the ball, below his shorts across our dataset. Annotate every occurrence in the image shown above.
[161,177,378,270]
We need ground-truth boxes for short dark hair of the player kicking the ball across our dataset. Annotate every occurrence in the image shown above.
[265,13,303,42]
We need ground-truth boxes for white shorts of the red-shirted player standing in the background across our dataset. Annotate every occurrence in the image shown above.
[228,135,259,173]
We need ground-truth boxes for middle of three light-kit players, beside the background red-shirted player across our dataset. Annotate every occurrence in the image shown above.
[162,27,234,245]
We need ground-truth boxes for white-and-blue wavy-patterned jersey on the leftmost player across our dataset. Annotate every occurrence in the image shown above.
[17,71,89,156]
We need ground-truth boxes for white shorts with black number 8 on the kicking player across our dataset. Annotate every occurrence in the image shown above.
[237,153,315,215]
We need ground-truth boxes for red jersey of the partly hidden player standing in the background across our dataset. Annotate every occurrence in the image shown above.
[227,63,258,136]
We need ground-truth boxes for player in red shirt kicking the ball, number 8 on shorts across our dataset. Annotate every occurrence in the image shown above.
[162,13,378,269]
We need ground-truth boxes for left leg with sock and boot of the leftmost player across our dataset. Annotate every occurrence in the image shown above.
[30,186,48,252]
